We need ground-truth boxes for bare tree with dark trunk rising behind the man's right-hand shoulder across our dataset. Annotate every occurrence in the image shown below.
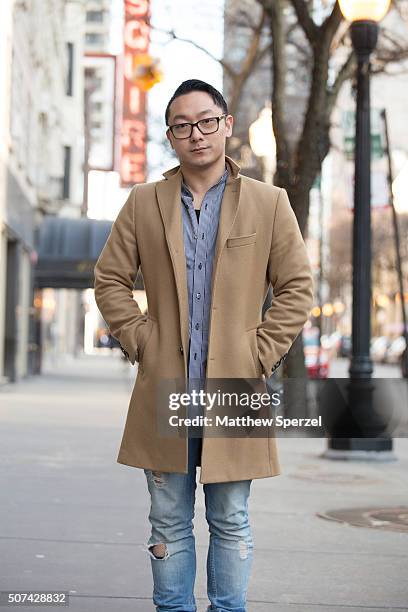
[151,0,408,376]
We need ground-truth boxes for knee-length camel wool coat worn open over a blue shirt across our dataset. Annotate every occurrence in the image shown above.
[95,156,313,484]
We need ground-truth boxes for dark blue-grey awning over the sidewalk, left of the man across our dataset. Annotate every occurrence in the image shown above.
[34,216,143,289]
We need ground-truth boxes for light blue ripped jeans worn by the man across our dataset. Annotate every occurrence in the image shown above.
[144,438,253,612]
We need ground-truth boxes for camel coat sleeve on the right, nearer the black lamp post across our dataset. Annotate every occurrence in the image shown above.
[257,189,313,378]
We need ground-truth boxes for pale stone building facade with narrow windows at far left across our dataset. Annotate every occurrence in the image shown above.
[0,0,84,382]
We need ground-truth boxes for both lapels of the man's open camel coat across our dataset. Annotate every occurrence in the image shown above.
[156,156,241,354]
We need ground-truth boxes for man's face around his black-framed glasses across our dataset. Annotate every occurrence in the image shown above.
[166,91,233,169]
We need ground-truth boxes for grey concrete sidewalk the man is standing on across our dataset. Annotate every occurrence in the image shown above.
[0,356,408,612]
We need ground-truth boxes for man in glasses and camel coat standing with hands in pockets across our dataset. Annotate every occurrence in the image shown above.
[95,79,312,612]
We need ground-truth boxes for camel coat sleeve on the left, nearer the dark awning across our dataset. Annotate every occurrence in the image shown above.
[94,186,147,364]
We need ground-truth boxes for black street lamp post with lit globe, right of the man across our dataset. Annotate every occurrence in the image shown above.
[327,0,392,458]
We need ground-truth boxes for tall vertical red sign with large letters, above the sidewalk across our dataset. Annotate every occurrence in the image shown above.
[120,0,150,187]
